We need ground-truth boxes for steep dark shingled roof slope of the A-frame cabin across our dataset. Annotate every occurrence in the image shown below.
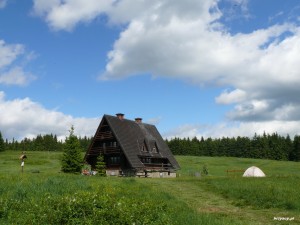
[94,115,180,169]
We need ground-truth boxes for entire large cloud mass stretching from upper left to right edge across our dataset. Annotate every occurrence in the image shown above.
[34,0,300,137]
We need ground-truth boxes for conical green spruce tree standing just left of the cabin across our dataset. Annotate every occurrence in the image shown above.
[61,126,82,173]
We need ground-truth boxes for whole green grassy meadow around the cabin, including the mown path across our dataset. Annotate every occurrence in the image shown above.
[0,151,300,225]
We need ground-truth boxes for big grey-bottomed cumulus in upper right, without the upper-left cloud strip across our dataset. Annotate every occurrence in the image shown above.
[100,1,300,125]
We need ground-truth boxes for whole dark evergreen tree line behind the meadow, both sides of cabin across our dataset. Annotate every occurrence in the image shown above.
[0,131,300,161]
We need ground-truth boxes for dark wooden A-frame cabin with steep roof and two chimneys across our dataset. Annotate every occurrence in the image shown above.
[85,113,180,177]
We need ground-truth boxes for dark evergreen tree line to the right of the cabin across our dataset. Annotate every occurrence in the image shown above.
[166,133,300,161]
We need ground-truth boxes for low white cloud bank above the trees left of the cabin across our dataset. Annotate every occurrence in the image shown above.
[0,92,100,140]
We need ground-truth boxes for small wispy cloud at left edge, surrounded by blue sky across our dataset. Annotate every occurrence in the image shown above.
[0,40,36,86]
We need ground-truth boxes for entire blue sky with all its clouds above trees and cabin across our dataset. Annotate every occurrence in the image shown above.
[0,0,300,139]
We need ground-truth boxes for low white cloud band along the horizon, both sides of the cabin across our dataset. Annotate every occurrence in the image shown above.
[0,91,300,140]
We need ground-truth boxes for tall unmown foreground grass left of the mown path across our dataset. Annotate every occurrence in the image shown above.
[0,174,225,224]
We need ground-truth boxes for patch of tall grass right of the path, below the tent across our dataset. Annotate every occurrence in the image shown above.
[202,177,300,212]
